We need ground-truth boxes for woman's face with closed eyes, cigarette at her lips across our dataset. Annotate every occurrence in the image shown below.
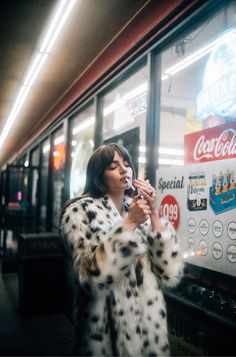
[104,152,133,193]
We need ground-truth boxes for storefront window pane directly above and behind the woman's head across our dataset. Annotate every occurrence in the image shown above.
[103,66,147,177]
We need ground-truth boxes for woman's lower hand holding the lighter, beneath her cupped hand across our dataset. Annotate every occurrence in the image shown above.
[124,194,151,230]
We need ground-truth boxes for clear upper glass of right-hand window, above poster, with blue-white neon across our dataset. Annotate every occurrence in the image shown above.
[159,3,236,167]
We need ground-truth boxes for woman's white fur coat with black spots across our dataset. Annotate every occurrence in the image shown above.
[61,195,183,356]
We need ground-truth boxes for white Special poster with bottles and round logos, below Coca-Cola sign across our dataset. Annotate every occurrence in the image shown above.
[156,159,236,276]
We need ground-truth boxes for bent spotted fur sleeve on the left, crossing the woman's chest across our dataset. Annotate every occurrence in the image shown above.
[61,201,146,290]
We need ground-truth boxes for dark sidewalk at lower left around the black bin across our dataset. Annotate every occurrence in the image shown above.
[0,260,73,356]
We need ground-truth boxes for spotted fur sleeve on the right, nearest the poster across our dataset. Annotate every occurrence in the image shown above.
[147,219,183,287]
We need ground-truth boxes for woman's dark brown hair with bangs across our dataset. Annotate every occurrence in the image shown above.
[83,143,135,198]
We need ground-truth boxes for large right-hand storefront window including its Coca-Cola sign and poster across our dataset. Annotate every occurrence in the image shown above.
[156,2,236,276]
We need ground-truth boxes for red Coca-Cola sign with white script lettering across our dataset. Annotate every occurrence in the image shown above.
[184,122,236,164]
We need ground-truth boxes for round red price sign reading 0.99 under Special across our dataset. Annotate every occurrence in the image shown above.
[159,195,180,230]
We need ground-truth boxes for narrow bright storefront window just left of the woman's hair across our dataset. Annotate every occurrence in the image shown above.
[70,105,95,198]
